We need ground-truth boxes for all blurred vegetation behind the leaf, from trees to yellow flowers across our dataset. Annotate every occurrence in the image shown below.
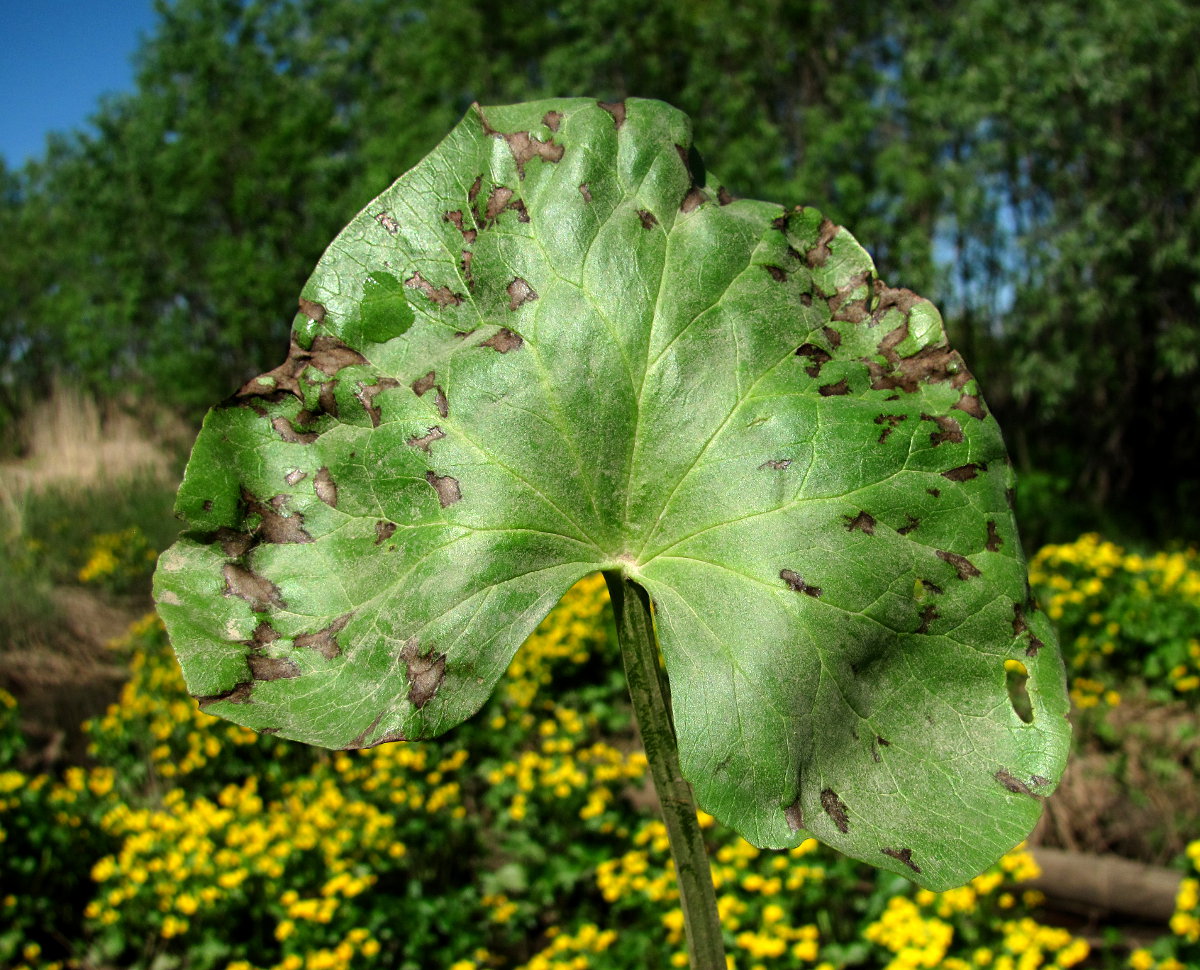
[0,0,1200,970]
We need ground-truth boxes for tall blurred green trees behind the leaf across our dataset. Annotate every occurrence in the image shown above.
[0,0,1200,539]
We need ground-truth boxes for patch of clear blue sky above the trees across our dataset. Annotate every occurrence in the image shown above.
[0,0,155,168]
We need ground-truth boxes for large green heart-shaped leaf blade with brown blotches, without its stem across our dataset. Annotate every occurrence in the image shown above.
[157,100,1068,887]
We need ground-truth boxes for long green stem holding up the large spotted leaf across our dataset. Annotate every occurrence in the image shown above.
[604,573,725,970]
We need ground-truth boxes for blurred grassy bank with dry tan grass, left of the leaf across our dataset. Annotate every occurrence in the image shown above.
[0,388,185,760]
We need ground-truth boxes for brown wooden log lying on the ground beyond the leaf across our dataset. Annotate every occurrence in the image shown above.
[1021,846,1183,923]
